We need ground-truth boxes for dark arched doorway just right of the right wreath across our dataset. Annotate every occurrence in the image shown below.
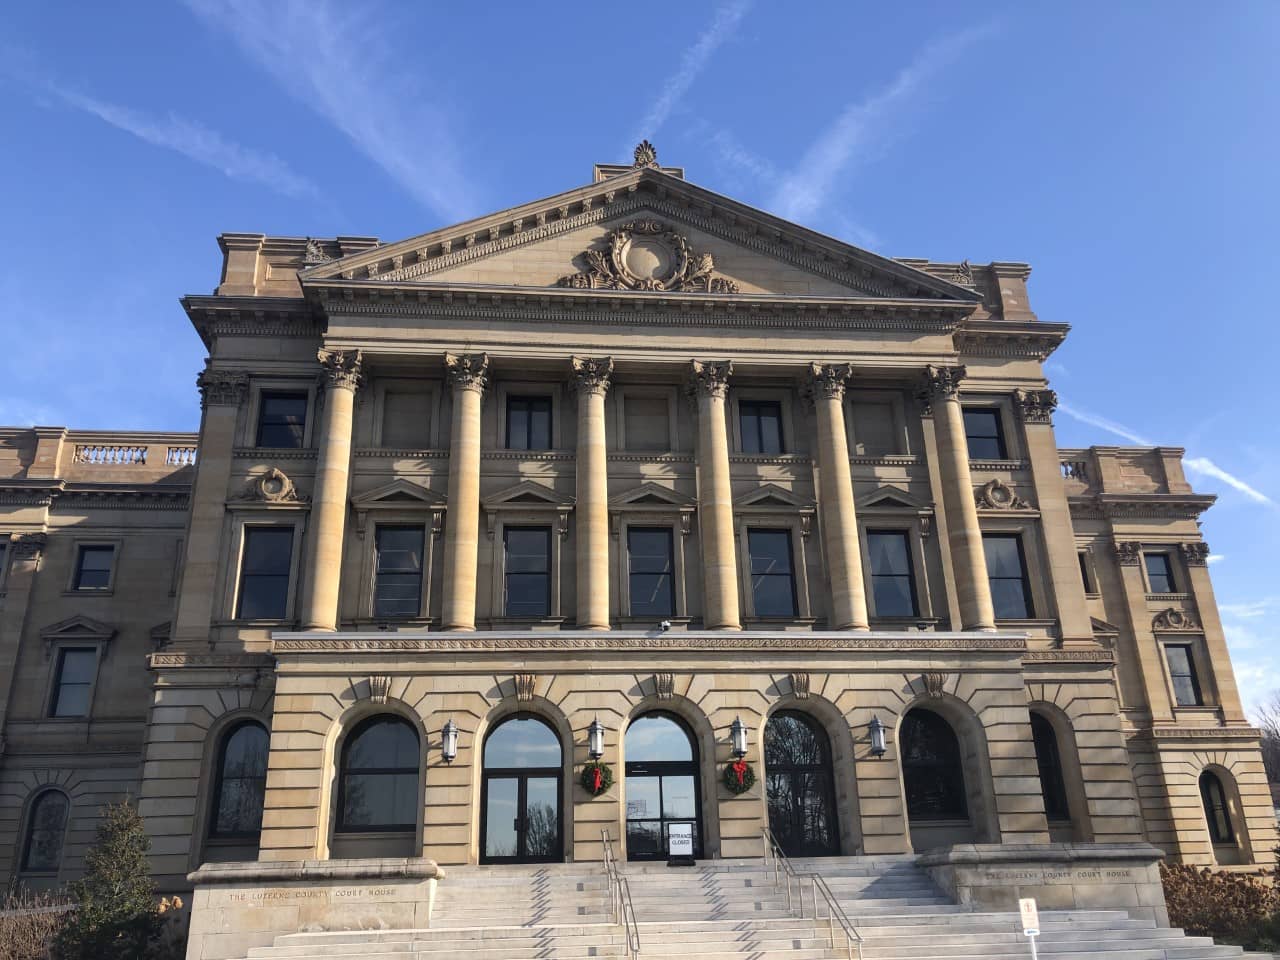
[764,710,840,856]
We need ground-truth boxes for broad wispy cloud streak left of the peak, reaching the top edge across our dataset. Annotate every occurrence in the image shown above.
[186,0,479,220]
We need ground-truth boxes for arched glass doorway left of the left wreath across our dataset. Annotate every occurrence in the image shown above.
[480,713,563,863]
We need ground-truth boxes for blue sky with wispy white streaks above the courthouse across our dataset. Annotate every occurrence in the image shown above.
[0,0,1280,703]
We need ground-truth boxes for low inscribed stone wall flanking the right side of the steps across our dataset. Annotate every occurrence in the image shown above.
[920,844,1169,927]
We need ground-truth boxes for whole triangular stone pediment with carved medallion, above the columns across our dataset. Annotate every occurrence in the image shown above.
[300,168,978,305]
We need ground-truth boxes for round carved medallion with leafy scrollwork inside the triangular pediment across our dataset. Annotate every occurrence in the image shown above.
[557,220,739,293]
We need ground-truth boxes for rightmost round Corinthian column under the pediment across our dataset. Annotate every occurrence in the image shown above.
[924,364,996,630]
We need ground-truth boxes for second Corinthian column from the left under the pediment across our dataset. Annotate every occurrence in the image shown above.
[442,353,489,630]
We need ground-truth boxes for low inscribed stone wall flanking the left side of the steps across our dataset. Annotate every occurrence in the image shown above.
[187,858,444,960]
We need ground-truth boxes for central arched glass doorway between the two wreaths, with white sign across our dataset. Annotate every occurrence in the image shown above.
[623,713,703,860]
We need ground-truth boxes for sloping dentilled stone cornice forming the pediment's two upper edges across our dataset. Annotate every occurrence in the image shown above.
[298,168,980,306]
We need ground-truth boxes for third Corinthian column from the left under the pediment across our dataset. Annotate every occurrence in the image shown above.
[572,357,613,630]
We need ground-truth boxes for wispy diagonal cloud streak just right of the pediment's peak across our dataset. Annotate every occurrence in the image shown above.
[771,24,992,221]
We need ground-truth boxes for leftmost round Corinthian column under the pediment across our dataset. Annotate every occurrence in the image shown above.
[302,349,361,630]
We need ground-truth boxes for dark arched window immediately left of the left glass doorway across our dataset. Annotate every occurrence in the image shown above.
[338,716,422,833]
